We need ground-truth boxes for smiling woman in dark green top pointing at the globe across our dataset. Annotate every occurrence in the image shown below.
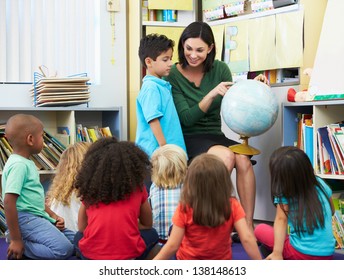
[166,22,266,232]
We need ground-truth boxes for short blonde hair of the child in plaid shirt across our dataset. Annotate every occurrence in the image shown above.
[151,144,187,188]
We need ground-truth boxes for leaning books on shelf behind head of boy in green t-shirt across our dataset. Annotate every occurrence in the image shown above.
[0,132,66,171]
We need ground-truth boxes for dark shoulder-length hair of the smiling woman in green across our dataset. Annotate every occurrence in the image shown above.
[178,21,216,72]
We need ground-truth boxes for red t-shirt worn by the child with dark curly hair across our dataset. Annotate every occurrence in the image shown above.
[79,188,148,260]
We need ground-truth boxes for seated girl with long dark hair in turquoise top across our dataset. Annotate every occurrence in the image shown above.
[254,146,335,260]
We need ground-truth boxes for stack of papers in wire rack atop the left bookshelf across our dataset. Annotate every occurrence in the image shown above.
[30,77,90,107]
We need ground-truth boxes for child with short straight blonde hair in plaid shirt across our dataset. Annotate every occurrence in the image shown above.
[149,144,187,243]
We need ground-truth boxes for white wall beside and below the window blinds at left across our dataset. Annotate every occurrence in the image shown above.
[0,0,128,139]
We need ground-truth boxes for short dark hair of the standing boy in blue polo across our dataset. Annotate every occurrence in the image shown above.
[139,33,174,68]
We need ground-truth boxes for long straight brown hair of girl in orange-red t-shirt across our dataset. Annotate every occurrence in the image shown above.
[181,153,233,227]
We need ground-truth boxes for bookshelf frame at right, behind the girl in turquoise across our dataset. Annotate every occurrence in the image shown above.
[282,100,344,186]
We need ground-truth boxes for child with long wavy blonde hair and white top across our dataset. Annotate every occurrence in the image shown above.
[47,142,91,232]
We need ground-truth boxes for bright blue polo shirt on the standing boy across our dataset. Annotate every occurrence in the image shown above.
[135,75,186,157]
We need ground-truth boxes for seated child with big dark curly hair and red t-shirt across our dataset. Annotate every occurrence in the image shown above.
[74,137,158,260]
